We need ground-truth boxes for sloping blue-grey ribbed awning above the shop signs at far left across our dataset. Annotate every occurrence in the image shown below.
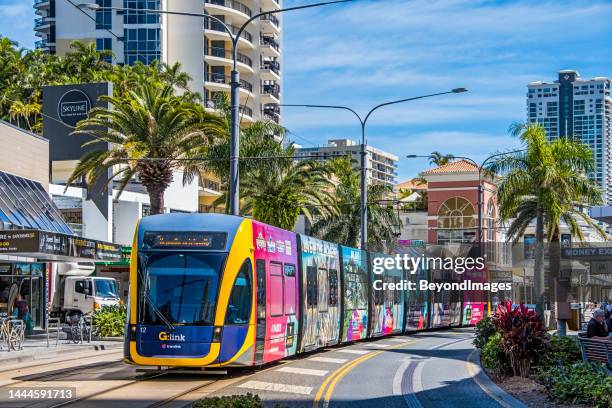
[0,171,73,235]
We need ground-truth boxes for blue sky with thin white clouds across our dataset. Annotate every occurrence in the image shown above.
[0,0,612,180]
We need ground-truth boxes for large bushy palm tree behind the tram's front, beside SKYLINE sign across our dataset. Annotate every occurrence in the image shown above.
[68,82,212,214]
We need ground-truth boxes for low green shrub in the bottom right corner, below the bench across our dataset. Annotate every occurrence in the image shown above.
[536,362,612,408]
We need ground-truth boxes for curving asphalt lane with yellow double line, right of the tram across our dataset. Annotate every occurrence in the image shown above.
[215,329,522,408]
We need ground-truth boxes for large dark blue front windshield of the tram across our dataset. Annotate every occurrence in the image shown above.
[138,253,227,325]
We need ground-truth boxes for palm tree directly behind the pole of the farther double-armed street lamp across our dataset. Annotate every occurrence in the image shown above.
[311,158,401,251]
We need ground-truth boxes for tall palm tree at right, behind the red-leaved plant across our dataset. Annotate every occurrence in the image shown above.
[488,124,605,332]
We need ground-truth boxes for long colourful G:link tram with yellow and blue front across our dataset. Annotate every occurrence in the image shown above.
[124,213,486,368]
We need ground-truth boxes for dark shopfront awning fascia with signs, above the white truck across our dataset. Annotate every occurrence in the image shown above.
[0,230,121,262]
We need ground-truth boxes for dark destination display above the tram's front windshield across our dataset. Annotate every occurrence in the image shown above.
[142,231,227,251]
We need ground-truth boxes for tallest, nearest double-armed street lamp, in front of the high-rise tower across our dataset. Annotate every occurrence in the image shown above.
[77,0,353,215]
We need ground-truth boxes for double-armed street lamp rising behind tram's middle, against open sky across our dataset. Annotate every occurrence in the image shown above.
[276,88,467,250]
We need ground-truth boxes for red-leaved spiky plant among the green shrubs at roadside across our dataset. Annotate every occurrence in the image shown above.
[493,301,548,377]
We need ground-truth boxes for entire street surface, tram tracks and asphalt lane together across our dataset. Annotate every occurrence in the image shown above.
[0,329,520,408]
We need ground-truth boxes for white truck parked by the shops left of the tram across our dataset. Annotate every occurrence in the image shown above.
[50,262,120,320]
